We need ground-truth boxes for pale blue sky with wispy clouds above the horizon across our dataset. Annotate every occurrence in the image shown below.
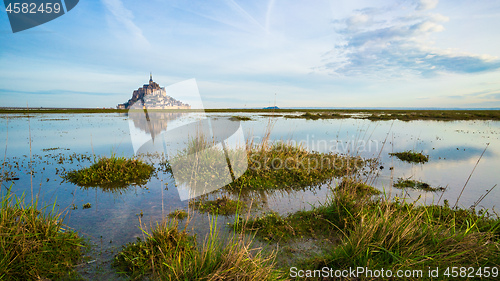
[0,0,500,108]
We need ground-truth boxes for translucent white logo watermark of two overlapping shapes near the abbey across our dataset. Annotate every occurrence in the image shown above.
[128,79,248,200]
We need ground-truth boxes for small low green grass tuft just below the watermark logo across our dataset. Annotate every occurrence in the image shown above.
[189,196,246,216]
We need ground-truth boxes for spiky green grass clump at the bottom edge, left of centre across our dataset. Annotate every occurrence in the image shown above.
[114,221,282,280]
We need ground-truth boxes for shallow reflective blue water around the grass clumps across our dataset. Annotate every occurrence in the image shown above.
[0,113,500,276]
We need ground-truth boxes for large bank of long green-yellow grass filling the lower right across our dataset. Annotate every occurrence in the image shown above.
[233,176,500,280]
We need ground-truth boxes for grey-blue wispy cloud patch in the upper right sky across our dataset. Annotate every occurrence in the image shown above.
[321,0,500,77]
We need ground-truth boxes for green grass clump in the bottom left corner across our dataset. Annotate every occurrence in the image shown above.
[0,187,84,280]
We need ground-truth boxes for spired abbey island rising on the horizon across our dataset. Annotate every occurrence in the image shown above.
[116,74,191,109]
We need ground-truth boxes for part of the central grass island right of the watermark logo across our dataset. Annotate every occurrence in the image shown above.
[225,143,365,191]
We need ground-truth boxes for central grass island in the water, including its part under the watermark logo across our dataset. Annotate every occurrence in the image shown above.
[169,126,367,194]
